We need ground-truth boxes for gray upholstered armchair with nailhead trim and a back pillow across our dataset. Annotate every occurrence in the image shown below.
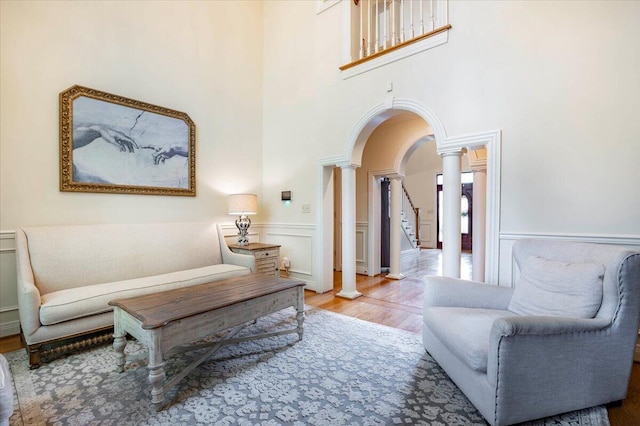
[423,239,640,425]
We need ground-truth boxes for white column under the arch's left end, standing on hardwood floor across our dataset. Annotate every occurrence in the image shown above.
[337,163,362,299]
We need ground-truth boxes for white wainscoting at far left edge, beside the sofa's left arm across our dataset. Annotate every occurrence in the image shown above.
[0,231,20,337]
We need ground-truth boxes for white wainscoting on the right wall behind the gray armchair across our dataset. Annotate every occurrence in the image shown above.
[498,233,640,361]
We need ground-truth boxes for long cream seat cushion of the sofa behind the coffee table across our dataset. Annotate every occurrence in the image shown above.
[40,264,251,325]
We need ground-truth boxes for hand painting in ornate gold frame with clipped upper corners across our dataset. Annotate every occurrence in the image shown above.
[60,86,196,197]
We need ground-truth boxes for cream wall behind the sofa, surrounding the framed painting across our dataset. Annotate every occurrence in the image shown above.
[0,1,263,333]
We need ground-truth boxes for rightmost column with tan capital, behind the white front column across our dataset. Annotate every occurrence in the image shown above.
[467,149,487,282]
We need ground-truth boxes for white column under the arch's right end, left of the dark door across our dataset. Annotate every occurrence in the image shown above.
[440,151,462,278]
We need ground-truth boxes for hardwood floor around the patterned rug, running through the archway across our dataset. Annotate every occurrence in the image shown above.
[0,250,640,426]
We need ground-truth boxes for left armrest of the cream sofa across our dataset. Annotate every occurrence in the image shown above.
[16,229,41,343]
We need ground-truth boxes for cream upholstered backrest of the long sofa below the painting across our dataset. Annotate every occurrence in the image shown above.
[23,222,223,294]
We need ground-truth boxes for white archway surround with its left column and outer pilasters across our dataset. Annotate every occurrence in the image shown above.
[316,98,501,298]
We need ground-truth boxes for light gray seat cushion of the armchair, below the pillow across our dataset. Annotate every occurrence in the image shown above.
[423,306,518,373]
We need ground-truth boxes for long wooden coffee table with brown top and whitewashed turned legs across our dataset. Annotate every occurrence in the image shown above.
[109,274,305,411]
